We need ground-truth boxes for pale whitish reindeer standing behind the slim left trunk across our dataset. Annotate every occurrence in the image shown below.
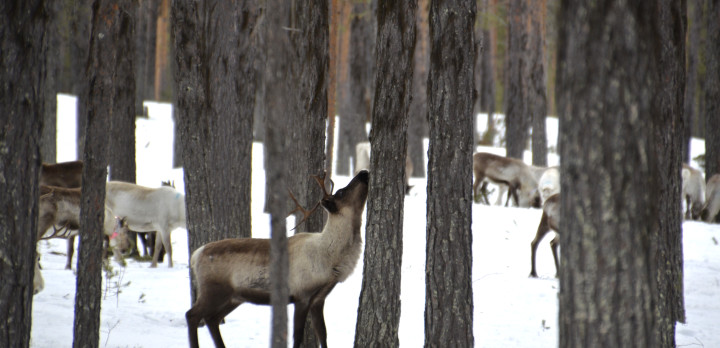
[105,181,186,268]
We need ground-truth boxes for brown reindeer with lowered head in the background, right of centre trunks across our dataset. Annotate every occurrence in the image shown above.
[473,152,540,208]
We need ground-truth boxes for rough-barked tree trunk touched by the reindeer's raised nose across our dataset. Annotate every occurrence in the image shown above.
[355,0,417,347]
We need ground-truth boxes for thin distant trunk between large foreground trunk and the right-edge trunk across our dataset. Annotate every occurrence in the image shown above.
[682,0,702,163]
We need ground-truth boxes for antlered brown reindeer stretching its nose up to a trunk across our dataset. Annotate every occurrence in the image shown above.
[185,170,369,348]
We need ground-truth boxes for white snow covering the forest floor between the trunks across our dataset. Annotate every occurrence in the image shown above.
[31,95,720,347]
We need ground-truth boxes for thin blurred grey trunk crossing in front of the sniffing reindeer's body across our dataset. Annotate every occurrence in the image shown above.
[261,0,295,348]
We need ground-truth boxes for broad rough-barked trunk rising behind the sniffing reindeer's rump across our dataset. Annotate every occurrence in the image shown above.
[171,0,255,253]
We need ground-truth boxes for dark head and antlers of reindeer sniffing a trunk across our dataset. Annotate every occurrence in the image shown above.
[288,170,370,230]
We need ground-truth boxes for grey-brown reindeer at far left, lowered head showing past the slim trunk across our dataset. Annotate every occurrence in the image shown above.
[37,185,130,269]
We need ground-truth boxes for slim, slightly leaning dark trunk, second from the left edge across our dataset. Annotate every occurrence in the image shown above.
[73,0,122,348]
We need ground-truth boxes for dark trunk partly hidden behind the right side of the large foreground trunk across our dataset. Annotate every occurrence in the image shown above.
[653,0,687,347]
